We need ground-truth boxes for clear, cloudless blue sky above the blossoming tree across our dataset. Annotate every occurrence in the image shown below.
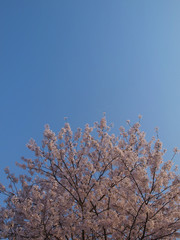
[0,0,180,188]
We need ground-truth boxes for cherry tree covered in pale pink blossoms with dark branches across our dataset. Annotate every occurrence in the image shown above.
[0,117,180,240]
